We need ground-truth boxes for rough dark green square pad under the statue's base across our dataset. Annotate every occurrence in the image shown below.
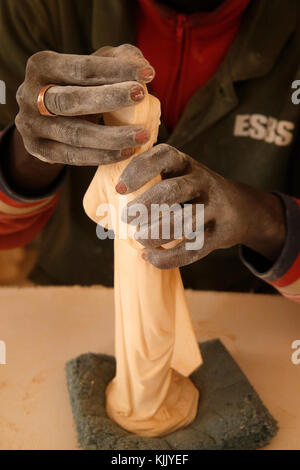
[66,340,278,450]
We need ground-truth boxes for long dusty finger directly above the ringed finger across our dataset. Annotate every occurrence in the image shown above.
[26,51,155,86]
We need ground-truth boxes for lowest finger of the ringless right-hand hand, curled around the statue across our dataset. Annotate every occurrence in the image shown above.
[142,230,217,269]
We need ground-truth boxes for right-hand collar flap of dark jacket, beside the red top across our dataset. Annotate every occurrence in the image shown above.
[168,0,297,148]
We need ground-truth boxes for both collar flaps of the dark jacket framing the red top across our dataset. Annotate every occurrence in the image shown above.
[91,0,299,148]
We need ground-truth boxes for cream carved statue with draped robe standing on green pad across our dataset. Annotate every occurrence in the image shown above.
[84,85,202,436]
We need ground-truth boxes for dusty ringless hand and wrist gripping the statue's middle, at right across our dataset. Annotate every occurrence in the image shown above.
[116,144,285,269]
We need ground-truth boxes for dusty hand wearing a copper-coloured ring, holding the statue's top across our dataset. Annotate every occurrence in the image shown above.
[16,44,154,165]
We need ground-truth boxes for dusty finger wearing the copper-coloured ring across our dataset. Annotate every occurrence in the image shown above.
[44,82,145,116]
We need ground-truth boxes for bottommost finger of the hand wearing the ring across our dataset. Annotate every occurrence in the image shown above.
[24,139,134,166]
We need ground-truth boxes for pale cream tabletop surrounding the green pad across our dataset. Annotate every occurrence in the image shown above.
[0,287,300,450]
